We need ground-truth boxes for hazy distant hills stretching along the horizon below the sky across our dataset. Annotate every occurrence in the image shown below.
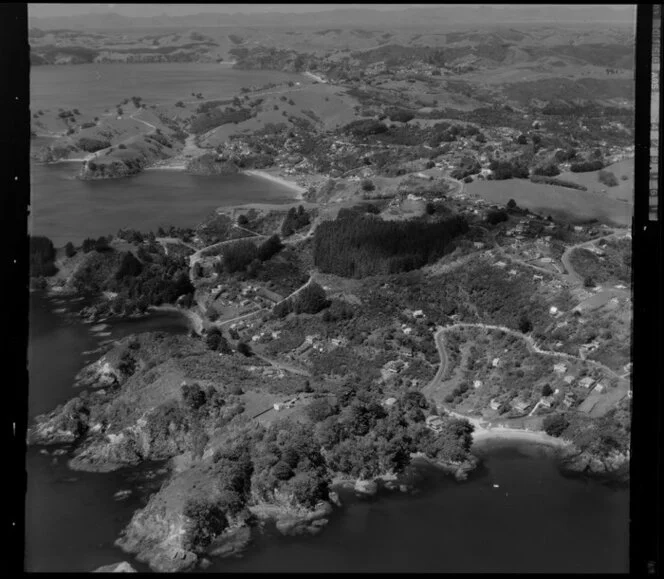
[29,4,636,30]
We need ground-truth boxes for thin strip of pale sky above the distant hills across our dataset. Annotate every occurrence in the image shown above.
[28,3,428,18]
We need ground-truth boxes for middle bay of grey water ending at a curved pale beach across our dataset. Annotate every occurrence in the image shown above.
[29,162,293,247]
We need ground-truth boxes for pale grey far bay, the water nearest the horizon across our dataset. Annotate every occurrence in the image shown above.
[30,62,302,114]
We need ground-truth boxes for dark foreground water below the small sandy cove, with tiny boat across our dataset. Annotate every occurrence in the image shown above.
[217,442,629,573]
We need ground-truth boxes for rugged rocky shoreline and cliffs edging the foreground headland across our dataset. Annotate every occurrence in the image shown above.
[28,296,629,572]
